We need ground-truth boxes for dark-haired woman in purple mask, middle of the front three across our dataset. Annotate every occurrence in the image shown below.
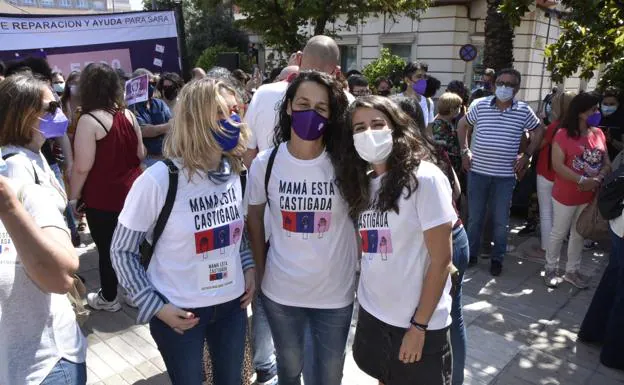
[248,72,357,385]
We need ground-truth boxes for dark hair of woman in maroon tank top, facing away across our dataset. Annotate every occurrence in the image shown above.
[78,63,124,113]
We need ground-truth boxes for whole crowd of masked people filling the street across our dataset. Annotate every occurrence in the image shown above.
[0,32,624,385]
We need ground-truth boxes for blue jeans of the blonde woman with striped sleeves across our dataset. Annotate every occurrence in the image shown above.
[150,299,247,385]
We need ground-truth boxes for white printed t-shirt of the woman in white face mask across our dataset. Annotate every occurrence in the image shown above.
[358,161,457,330]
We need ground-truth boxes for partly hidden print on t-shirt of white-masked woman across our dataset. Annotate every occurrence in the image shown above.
[358,211,392,261]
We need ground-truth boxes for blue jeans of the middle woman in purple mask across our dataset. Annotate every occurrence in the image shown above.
[261,294,353,385]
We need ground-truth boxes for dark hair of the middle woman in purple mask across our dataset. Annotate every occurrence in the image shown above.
[273,71,349,160]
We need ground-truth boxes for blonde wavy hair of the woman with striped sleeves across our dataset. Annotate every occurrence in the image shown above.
[163,78,249,178]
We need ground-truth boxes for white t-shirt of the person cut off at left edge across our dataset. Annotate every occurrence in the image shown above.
[0,180,87,385]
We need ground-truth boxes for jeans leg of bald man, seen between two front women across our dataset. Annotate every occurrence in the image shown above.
[251,296,277,375]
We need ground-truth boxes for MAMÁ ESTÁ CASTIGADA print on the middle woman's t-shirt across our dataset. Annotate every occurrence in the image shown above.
[279,181,336,239]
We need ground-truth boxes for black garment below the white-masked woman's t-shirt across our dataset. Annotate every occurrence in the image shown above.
[353,307,453,385]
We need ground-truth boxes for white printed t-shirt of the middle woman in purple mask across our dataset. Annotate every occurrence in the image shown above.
[249,144,357,309]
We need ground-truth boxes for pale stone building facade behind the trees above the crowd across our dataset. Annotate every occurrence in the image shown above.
[245,0,596,107]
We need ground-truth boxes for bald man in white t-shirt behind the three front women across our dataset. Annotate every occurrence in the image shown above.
[244,35,355,385]
